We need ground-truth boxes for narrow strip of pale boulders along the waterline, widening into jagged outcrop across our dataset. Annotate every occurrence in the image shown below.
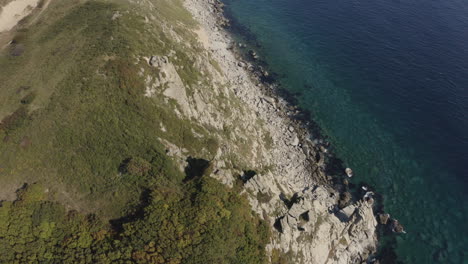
[185,0,388,263]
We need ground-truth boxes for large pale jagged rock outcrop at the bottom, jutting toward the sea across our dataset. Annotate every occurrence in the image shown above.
[246,175,377,263]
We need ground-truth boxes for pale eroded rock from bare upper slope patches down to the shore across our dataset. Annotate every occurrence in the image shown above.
[142,0,377,263]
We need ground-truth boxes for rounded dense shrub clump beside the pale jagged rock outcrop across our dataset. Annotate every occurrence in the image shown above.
[116,177,268,263]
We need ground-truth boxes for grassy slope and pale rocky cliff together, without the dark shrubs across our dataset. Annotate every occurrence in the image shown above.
[0,0,377,263]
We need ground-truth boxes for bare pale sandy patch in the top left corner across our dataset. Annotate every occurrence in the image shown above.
[0,0,39,32]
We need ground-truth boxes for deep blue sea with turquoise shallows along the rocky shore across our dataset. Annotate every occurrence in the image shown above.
[224,0,468,263]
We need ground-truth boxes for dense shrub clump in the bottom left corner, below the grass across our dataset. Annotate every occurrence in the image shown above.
[0,185,100,263]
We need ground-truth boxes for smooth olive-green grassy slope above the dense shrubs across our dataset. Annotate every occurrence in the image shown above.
[0,0,219,217]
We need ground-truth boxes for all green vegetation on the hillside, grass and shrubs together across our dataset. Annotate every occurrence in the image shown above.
[0,0,269,263]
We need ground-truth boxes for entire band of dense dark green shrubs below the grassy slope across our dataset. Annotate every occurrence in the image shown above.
[0,176,269,264]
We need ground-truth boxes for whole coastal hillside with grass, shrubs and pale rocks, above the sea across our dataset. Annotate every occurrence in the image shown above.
[0,0,375,263]
